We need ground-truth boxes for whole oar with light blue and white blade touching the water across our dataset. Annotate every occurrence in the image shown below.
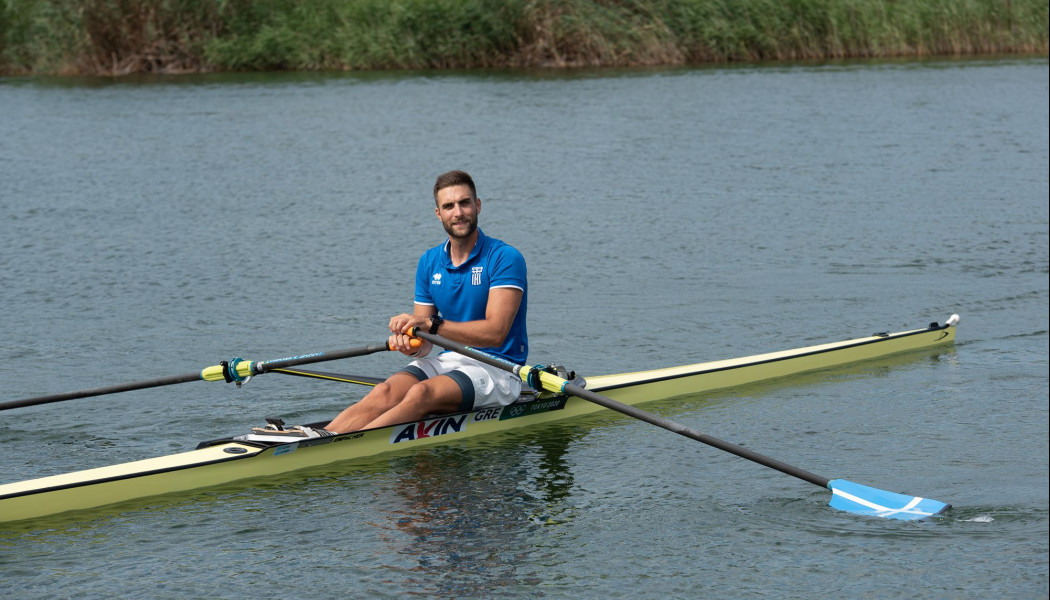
[412,330,951,520]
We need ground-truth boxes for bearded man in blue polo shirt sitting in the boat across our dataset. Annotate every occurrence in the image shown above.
[319,170,528,435]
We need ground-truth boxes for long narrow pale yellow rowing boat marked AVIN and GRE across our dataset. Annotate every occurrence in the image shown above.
[0,315,958,522]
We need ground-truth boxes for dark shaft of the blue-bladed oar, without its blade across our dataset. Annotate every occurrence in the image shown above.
[413,330,831,488]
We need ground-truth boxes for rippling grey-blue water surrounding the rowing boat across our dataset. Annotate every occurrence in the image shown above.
[0,59,1050,598]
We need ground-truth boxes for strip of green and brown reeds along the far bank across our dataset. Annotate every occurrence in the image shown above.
[0,0,1048,75]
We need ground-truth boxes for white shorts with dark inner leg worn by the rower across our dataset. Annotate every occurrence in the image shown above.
[401,352,522,413]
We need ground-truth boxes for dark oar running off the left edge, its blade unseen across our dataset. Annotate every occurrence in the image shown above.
[0,344,417,411]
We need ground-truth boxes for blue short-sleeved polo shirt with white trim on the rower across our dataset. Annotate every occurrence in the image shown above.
[416,229,528,365]
